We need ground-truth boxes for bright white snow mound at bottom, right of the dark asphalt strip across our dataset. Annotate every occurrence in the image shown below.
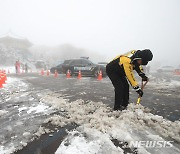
[55,127,123,154]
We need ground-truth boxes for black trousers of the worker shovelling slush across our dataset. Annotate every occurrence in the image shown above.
[106,63,129,110]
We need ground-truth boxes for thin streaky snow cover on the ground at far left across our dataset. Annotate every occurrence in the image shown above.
[0,77,52,154]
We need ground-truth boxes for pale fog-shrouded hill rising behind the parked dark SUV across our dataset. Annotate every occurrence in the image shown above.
[29,44,106,65]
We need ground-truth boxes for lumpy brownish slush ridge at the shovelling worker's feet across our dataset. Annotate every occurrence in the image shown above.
[42,94,180,142]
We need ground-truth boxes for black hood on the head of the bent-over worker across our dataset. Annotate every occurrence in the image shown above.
[134,49,153,65]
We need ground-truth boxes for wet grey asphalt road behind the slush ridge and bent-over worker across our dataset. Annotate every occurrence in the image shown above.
[9,73,180,121]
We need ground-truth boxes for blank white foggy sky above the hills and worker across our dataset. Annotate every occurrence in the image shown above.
[0,0,180,64]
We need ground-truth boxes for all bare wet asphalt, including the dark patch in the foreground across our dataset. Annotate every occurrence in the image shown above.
[4,73,180,154]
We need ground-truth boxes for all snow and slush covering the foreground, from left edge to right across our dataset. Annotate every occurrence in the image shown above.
[0,77,180,154]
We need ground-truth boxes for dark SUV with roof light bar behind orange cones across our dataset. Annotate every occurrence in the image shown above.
[61,58,106,77]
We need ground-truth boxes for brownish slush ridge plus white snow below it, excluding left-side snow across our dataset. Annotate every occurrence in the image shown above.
[42,94,180,154]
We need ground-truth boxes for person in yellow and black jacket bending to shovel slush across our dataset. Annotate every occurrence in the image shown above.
[106,49,153,110]
